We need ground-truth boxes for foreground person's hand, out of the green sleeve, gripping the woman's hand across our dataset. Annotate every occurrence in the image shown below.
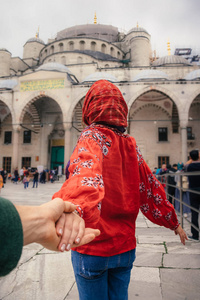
[16,198,99,251]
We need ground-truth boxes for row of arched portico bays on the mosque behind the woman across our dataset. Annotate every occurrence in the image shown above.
[0,86,200,172]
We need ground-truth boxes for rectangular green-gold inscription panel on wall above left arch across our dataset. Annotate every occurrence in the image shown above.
[20,79,64,92]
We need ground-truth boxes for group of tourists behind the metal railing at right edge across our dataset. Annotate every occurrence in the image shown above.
[154,150,200,240]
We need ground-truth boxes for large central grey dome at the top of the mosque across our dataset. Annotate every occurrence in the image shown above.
[56,24,118,42]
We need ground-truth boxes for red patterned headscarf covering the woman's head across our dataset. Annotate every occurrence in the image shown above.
[83,80,128,127]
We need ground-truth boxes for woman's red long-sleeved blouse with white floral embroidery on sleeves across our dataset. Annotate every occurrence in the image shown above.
[53,124,179,256]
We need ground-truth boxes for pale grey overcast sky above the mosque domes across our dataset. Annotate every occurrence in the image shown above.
[0,0,200,58]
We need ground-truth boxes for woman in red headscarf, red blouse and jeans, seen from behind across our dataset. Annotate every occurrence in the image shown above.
[54,80,187,300]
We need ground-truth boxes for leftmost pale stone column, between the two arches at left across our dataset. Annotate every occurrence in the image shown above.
[11,125,21,171]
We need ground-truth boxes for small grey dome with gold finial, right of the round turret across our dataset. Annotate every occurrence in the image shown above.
[152,55,191,67]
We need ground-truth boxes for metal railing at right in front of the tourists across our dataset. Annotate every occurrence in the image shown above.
[156,172,200,232]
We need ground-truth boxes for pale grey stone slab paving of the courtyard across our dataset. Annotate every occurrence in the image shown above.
[0,182,200,300]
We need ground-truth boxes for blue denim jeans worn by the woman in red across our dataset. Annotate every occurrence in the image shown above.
[71,249,135,300]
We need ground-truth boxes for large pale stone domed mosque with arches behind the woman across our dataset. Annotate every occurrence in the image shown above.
[0,15,200,172]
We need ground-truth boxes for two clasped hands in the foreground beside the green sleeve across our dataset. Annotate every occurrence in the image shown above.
[16,198,100,252]
